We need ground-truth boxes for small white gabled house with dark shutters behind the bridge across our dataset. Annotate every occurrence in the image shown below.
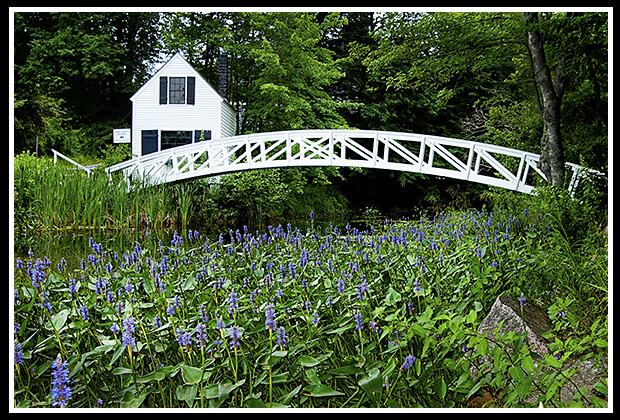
[131,53,236,156]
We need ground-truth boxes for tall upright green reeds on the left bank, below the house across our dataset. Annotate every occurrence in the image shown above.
[14,154,184,236]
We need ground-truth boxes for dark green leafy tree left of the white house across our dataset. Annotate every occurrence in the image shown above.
[14,12,159,154]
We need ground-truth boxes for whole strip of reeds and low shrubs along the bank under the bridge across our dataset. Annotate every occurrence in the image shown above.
[14,153,347,238]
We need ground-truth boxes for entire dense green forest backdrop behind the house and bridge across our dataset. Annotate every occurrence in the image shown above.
[12,9,609,217]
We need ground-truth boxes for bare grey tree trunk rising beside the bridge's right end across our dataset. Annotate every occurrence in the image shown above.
[523,12,566,188]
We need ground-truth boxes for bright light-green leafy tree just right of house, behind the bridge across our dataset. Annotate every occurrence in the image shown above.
[244,13,346,131]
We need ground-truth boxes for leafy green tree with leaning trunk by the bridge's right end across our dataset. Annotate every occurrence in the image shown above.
[358,12,607,186]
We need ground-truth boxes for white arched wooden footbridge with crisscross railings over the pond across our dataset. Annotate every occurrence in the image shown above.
[106,130,596,193]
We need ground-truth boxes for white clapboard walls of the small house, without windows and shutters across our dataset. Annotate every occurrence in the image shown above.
[131,53,236,156]
